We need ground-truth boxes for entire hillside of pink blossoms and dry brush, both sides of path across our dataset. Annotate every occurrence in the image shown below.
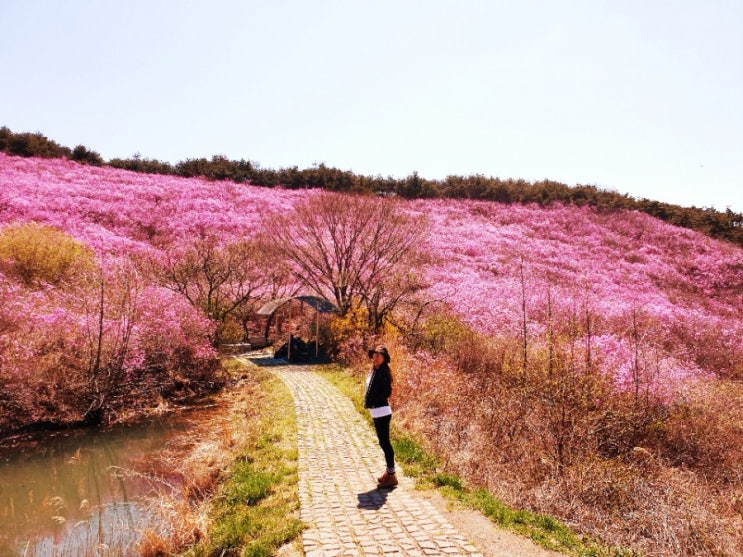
[0,153,743,555]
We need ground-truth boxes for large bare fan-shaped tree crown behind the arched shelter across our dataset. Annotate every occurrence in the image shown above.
[264,193,426,329]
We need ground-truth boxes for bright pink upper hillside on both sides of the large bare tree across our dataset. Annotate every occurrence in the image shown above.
[0,154,743,394]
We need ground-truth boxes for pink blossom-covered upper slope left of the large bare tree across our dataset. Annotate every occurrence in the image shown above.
[0,153,304,250]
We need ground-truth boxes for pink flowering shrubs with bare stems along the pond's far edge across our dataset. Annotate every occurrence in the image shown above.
[0,254,220,429]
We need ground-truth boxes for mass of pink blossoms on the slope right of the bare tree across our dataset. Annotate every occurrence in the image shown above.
[410,200,743,394]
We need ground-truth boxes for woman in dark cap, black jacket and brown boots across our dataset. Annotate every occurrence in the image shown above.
[364,346,397,487]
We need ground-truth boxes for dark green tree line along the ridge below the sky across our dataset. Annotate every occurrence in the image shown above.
[0,127,743,246]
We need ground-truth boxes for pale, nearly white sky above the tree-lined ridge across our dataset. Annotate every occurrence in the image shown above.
[0,0,743,212]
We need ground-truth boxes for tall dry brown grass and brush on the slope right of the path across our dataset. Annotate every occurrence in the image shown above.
[358,331,743,557]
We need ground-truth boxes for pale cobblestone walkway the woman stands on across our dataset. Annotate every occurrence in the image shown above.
[244,358,482,557]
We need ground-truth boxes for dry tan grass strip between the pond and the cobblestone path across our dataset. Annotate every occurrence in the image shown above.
[137,356,297,557]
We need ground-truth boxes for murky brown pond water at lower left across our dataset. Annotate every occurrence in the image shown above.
[0,410,199,557]
